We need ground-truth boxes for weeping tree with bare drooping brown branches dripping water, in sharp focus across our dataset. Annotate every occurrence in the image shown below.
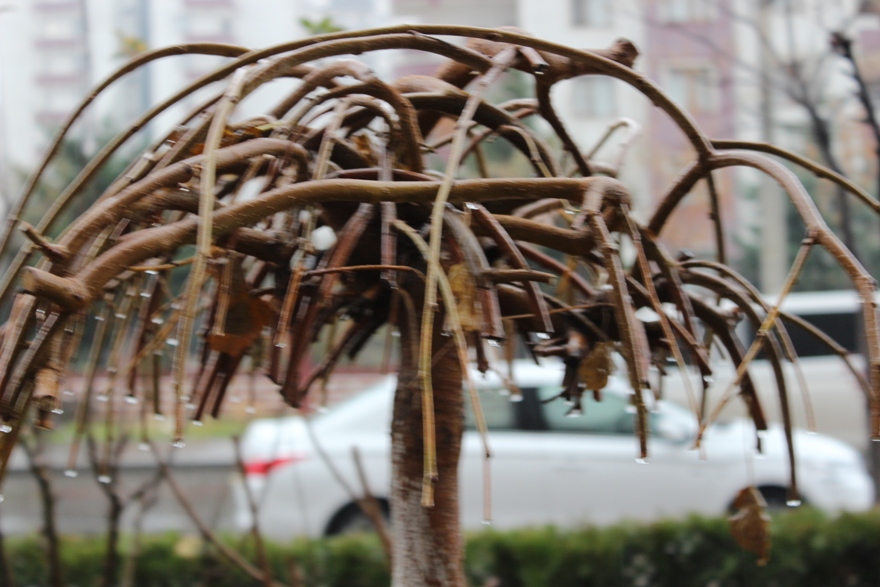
[0,26,880,586]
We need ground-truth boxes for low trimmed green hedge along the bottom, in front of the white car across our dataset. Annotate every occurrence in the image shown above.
[6,510,880,587]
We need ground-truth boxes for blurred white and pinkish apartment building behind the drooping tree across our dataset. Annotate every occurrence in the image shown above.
[0,0,880,291]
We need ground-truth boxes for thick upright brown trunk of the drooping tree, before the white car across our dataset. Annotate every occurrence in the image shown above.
[391,290,466,587]
